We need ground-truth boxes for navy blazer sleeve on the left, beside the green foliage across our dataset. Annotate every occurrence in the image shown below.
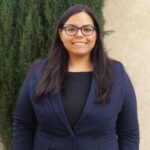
[12,68,36,150]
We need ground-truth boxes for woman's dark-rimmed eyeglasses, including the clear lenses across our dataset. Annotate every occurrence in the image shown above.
[62,25,95,36]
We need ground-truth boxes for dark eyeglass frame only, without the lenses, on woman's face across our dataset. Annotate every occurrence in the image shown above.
[61,24,96,36]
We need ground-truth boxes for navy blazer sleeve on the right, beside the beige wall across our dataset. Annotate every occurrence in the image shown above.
[117,64,139,150]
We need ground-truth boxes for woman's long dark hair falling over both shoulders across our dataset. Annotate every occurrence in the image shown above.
[36,4,112,103]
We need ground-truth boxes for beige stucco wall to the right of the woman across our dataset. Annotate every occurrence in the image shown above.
[103,0,150,150]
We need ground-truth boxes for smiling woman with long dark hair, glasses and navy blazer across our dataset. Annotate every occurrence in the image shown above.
[13,5,139,150]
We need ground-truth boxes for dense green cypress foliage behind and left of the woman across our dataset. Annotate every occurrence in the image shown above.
[0,0,104,150]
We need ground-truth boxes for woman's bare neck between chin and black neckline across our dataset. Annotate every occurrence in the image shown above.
[68,57,93,72]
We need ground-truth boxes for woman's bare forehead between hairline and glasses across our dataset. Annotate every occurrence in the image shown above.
[64,12,94,26]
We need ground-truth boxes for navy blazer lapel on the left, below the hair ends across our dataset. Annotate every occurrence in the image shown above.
[51,93,75,138]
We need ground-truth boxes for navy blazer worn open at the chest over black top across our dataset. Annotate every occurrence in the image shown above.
[12,62,139,150]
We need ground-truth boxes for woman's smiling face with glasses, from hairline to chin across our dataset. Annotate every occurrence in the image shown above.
[59,12,96,56]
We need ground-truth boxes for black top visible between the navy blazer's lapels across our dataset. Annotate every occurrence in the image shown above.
[61,72,92,127]
